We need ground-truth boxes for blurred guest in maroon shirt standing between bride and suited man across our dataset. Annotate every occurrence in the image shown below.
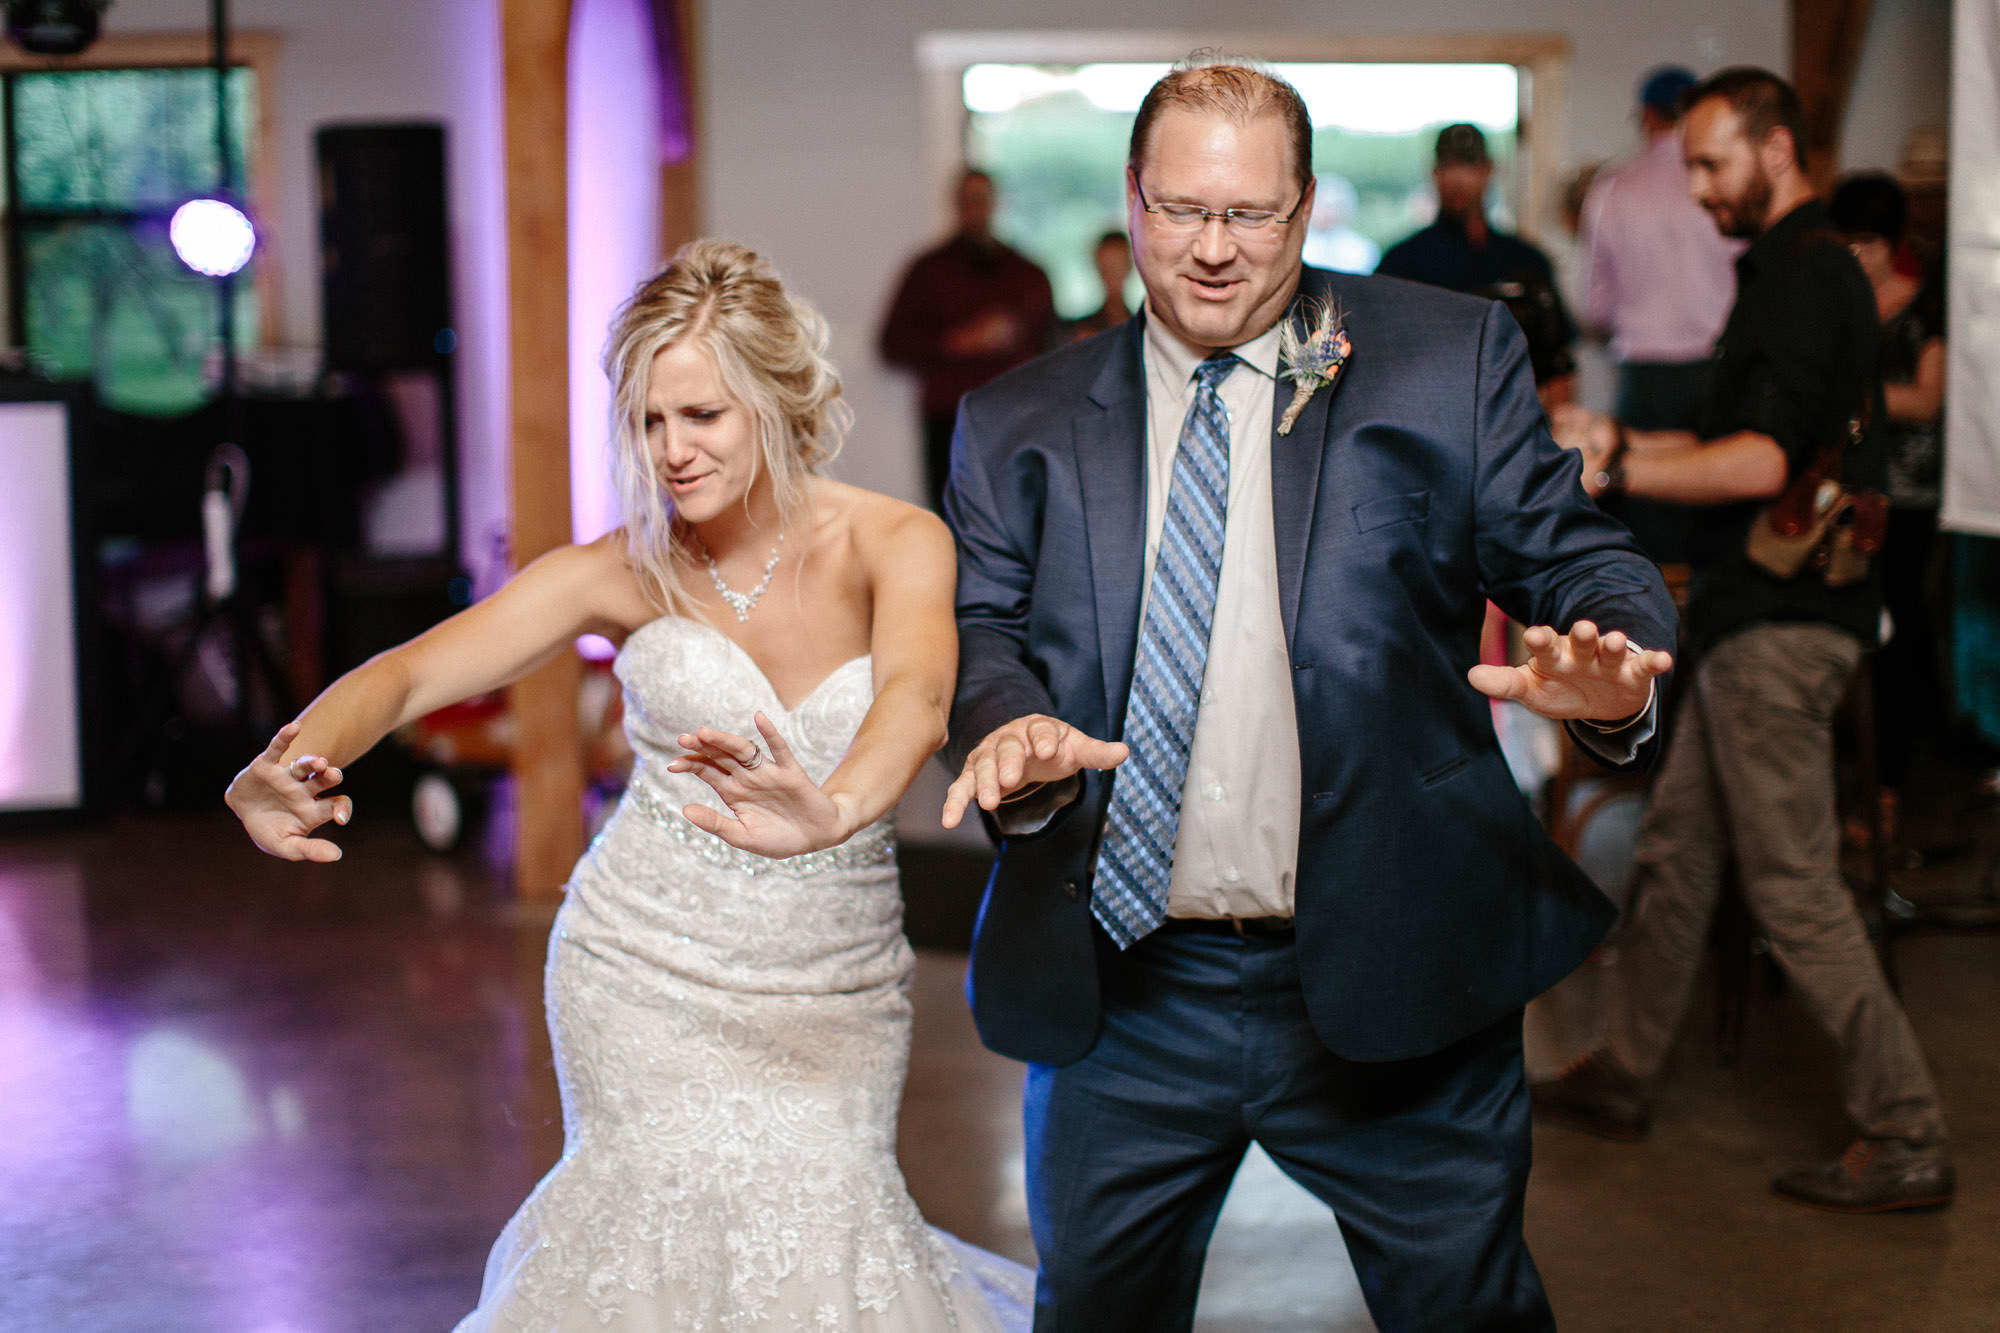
[880,170,1056,504]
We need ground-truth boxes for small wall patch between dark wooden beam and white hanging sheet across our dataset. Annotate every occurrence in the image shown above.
[1840,0,1952,172]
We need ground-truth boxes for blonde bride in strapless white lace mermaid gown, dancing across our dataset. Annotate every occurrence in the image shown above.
[228,240,1032,1333]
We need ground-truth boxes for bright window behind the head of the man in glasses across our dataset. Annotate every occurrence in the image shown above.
[962,62,1522,318]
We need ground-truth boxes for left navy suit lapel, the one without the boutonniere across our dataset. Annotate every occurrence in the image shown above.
[1072,314,1146,733]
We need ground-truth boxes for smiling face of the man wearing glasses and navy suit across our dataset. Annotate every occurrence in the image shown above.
[1126,108,1312,348]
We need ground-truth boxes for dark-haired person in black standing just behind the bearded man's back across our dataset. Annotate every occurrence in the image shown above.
[1828,172,1946,845]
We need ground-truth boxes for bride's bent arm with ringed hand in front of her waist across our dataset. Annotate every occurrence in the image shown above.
[674,496,958,857]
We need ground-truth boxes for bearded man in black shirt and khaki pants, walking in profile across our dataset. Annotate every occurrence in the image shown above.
[1534,68,1954,1213]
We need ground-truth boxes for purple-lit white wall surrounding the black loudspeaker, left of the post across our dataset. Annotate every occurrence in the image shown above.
[104,0,512,572]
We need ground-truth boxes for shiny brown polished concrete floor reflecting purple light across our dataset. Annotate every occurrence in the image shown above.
[0,788,2000,1333]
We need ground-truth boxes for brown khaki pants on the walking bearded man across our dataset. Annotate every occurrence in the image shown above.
[1606,624,1944,1145]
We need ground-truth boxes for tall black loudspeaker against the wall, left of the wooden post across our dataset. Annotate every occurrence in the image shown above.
[314,122,452,372]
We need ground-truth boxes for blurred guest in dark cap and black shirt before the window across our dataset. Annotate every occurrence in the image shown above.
[1376,124,1576,404]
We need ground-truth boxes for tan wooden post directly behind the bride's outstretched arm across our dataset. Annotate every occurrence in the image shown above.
[500,0,584,899]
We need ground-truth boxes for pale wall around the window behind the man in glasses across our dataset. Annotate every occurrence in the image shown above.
[698,0,1784,498]
